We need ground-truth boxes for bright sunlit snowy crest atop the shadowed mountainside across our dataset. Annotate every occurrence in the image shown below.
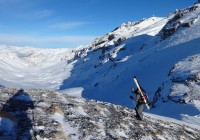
[91,17,168,49]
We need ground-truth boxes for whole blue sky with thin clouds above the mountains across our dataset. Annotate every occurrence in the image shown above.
[0,0,196,48]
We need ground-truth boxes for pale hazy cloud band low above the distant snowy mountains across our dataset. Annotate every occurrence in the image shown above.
[0,34,96,48]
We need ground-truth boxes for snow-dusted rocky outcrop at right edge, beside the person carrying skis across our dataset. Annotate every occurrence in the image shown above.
[153,55,200,105]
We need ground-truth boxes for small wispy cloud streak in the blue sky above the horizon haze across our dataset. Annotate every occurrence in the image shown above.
[50,22,92,30]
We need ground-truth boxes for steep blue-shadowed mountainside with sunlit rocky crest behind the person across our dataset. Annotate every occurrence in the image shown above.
[61,4,200,124]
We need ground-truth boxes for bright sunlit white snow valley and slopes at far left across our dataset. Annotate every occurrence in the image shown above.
[0,46,74,89]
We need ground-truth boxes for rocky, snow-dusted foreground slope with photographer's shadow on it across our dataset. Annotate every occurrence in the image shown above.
[0,88,200,140]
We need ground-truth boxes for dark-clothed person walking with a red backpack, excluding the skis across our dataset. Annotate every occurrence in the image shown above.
[130,88,147,120]
